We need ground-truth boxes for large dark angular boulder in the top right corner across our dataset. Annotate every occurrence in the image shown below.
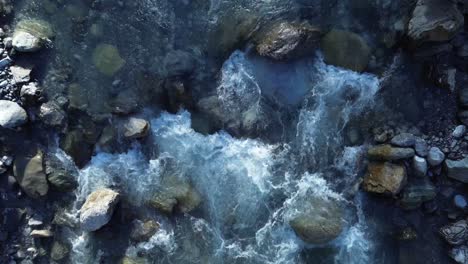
[408,0,464,41]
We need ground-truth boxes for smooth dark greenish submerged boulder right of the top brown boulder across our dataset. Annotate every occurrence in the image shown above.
[322,30,371,72]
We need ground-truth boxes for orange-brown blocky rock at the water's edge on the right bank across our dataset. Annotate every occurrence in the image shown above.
[362,162,406,195]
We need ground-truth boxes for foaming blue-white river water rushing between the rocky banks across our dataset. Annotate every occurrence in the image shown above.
[8,0,394,264]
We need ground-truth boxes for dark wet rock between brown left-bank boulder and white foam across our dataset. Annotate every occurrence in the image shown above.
[45,154,78,192]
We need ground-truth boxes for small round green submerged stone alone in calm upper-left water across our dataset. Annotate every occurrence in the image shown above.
[93,44,125,76]
